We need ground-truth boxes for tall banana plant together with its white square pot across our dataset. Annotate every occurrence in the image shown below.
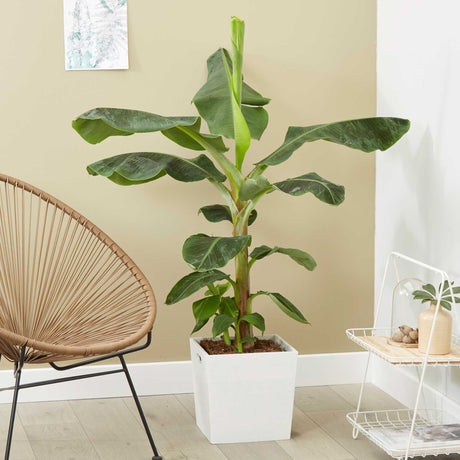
[73,17,409,442]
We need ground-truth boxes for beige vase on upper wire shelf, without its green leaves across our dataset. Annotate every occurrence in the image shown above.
[418,304,452,355]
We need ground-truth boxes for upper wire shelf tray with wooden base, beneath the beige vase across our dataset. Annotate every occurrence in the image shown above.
[346,328,460,366]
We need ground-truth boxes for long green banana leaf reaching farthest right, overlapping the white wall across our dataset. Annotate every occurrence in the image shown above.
[256,117,410,166]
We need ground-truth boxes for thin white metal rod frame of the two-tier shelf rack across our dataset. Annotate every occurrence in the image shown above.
[347,252,460,460]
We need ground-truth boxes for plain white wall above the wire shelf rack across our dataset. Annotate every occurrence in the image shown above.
[375,0,460,401]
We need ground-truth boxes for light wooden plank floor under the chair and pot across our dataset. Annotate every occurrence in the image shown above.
[0,385,460,460]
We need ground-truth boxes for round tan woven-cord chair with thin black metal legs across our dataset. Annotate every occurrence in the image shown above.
[0,175,161,459]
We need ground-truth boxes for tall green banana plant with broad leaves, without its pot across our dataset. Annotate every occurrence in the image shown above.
[72,17,410,352]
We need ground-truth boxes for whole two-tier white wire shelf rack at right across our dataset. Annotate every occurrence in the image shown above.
[346,252,460,459]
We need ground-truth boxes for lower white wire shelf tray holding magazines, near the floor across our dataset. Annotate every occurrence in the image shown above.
[347,409,460,459]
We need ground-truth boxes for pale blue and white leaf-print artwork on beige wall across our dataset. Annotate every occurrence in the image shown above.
[64,0,129,70]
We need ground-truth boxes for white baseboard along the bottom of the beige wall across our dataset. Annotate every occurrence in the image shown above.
[0,352,367,403]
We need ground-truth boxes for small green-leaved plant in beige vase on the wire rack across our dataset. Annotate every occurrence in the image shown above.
[412,281,460,355]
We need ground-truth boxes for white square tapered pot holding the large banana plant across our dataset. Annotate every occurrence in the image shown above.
[190,335,298,444]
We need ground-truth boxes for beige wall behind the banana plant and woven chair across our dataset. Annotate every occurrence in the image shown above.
[0,0,376,361]
